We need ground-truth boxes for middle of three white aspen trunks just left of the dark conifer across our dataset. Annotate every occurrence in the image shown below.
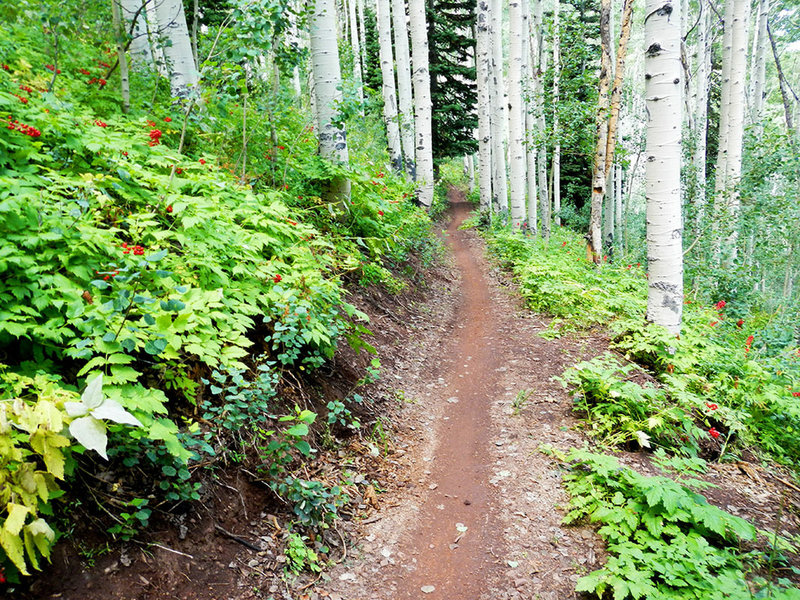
[392,0,416,179]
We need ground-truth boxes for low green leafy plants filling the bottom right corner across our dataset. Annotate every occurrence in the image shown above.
[543,448,800,600]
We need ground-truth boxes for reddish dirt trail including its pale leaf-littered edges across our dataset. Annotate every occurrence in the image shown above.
[319,191,602,600]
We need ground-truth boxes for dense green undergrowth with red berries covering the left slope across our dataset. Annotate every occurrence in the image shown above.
[0,2,437,585]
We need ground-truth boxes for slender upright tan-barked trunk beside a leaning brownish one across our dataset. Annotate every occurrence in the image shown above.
[589,0,611,263]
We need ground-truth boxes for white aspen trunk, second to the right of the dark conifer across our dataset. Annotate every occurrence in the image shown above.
[489,0,508,212]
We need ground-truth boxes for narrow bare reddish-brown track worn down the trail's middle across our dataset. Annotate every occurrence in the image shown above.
[386,203,503,598]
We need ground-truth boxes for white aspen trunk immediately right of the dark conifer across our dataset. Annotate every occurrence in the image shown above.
[475,0,493,212]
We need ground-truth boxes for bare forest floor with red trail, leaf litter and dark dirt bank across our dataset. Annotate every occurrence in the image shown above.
[20,191,798,600]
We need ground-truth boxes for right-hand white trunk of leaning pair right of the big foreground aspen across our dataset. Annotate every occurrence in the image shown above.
[723,0,750,264]
